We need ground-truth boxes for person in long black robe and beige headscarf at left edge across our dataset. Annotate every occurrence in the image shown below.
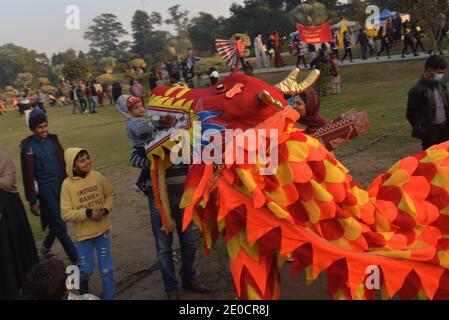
[0,150,39,300]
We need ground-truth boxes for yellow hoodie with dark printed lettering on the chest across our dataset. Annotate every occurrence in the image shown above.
[61,148,115,241]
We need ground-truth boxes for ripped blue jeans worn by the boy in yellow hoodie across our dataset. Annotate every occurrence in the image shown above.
[76,232,115,300]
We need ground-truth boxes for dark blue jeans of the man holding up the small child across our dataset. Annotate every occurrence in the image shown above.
[148,186,196,293]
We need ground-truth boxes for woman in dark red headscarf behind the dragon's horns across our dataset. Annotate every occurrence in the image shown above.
[292,89,327,134]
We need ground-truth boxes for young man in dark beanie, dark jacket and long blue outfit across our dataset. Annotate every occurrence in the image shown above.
[20,109,79,264]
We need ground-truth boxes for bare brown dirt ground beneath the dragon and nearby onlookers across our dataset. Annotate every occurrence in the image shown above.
[41,141,411,300]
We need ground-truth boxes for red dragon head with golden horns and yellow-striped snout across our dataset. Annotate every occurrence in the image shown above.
[149,69,320,130]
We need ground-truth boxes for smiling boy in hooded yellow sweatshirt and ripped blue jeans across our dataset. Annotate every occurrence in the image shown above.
[61,148,116,300]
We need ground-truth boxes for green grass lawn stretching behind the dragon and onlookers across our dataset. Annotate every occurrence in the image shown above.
[0,55,446,239]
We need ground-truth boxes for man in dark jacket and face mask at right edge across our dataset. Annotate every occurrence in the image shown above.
[406,56,449,150]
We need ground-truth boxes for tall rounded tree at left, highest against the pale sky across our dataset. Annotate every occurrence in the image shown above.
[84,13,129,57]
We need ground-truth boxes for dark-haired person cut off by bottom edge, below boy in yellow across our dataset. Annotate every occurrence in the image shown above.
[22,258,100,300]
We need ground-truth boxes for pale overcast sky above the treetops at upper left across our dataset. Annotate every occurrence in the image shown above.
[0,0,243,56]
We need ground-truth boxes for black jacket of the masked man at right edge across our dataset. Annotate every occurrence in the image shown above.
[406,79,449,138]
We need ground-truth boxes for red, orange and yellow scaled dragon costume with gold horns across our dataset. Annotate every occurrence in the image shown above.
[144,69,449,299]
